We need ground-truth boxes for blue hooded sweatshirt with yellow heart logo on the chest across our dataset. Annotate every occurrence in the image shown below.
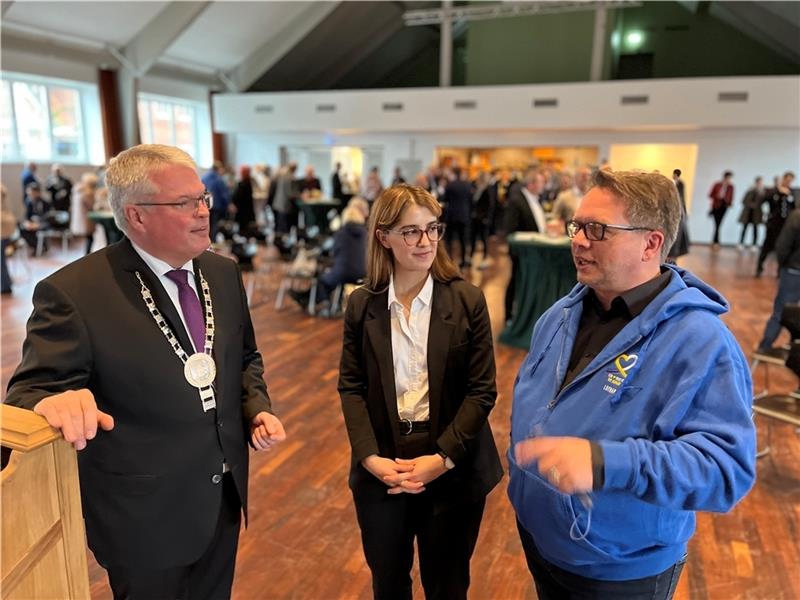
[508,267,755,581]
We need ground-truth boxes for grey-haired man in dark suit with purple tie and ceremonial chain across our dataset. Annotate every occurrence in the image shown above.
[6,145,285,600]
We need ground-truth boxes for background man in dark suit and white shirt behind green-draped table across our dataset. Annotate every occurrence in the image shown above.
[505,169,547,321]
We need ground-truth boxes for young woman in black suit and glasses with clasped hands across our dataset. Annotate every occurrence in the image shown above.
[339,185,502,600]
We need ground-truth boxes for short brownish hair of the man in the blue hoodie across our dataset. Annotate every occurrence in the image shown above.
[593,169,681,262]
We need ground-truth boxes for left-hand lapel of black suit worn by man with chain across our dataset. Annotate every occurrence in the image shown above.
[109,237,200,354]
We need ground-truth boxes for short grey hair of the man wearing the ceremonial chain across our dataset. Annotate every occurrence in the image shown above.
[106,144,197,233]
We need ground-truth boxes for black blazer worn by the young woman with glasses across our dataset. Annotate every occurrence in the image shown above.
[339,280,503,506]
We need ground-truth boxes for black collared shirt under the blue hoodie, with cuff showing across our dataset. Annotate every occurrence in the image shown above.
[561,267,672,490]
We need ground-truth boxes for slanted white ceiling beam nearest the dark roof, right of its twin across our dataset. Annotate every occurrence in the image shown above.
[223,2,340,92]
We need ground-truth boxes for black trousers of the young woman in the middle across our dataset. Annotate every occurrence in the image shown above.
[355,433,486,600]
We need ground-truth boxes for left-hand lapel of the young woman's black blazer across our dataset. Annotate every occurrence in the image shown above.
[364,290,400,444]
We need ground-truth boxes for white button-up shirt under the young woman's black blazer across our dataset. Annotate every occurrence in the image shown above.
[389,275,433,421]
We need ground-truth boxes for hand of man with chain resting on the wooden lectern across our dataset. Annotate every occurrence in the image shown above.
[33,388,114,450]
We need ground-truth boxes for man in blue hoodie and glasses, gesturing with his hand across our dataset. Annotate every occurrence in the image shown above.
[508,171,755,600]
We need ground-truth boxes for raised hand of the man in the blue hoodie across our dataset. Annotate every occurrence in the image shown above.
[514,437,593,494]
